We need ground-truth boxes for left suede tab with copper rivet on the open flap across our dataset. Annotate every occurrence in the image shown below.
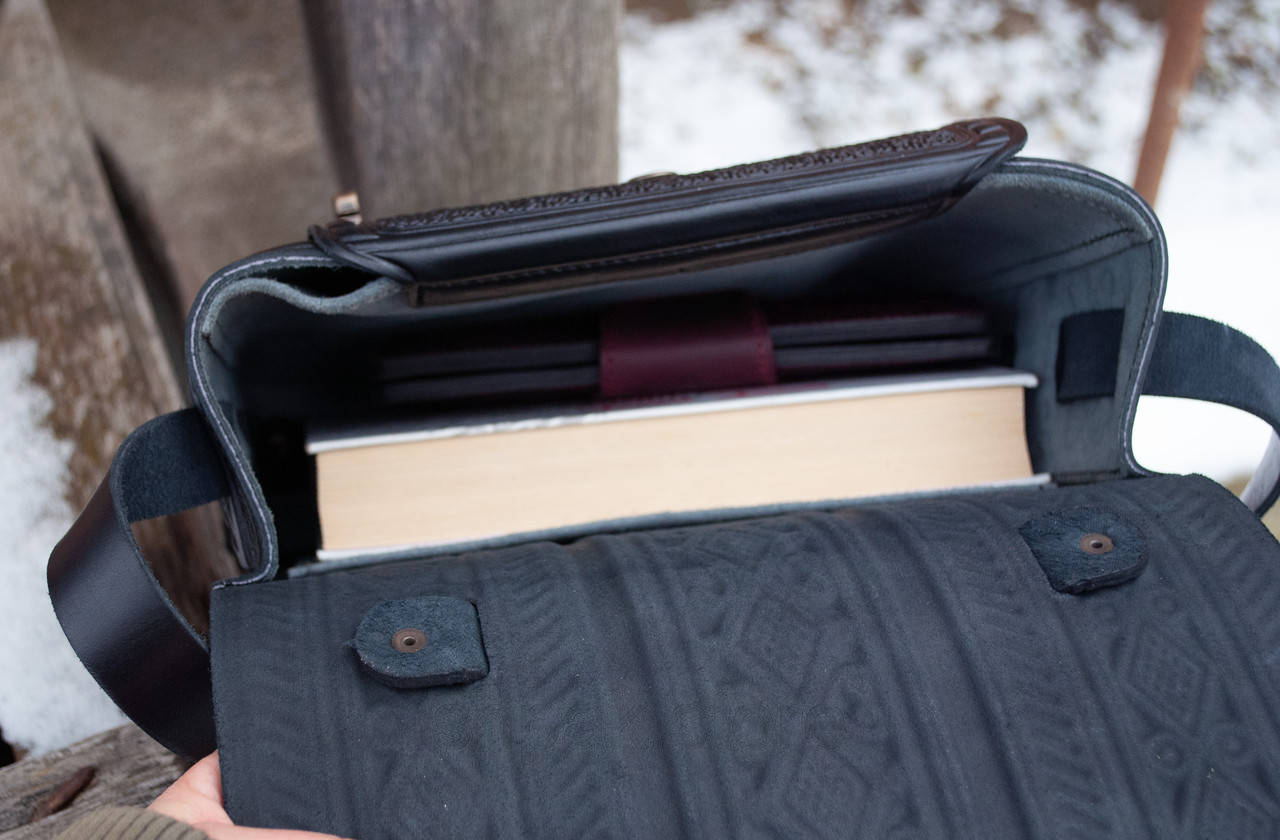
[351,595,489,689]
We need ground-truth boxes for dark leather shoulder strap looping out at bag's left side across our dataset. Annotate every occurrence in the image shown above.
[49,408,227,758]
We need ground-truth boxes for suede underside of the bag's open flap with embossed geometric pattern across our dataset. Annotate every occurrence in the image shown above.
[212,476,1280,840]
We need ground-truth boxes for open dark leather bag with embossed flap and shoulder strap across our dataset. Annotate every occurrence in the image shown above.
[49,119,1280,840]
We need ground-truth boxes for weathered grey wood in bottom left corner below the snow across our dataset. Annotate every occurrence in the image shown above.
[0,727,186,840]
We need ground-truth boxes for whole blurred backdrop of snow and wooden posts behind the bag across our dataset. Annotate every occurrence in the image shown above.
[0,0,1280,824]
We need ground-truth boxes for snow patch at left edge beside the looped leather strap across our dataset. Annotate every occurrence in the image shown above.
[0,339,124,753]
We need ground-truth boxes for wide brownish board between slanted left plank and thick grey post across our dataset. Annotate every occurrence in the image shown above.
[47,0,338,311]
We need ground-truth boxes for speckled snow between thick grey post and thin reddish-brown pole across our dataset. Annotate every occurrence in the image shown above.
[622,0,1161,178]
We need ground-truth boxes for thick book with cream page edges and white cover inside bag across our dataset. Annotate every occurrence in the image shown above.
[307,369,1041,558]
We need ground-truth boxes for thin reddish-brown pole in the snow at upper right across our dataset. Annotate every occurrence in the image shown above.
[1133,0,1208,206]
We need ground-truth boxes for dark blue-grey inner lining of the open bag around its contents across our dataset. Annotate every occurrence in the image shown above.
[192,161,1164,567]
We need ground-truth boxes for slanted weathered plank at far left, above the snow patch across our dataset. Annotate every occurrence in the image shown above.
[0,0,182,501]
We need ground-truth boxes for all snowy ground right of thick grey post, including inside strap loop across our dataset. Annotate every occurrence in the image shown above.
[621,0,1280,480]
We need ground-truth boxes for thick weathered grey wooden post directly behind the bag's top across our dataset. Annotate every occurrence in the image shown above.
[302,0,621,218]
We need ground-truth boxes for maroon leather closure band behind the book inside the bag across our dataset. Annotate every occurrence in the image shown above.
[600,295,778,400]
